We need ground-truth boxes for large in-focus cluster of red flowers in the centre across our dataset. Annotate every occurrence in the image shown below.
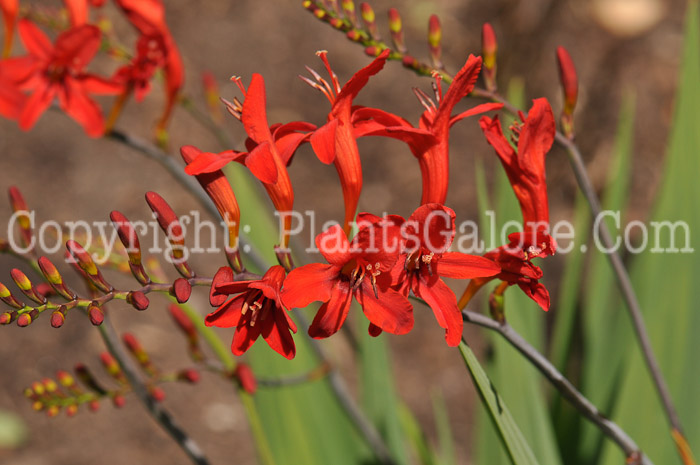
[187,50,556,358]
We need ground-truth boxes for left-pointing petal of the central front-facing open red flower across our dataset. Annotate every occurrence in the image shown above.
[281,263,338,308]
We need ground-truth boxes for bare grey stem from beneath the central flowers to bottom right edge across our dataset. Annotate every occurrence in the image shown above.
[462,310,652,465]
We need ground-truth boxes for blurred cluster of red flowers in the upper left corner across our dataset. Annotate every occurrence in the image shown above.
[0,0,184,137]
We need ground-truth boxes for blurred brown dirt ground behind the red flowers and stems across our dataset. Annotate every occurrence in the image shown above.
[0,0,685,465]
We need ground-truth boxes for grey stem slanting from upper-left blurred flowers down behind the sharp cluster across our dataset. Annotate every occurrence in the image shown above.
[105,129,268,270]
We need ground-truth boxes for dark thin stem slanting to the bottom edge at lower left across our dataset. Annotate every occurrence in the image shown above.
[99,315,209,465]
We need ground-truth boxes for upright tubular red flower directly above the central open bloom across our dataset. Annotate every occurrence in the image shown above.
[303,50,389,234]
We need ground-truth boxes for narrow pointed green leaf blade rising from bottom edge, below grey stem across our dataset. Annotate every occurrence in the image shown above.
[459,342,538,465]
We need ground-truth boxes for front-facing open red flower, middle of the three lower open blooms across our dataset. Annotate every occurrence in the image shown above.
[282,218,413,339]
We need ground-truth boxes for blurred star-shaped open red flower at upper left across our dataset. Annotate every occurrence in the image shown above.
[0,20,119,137]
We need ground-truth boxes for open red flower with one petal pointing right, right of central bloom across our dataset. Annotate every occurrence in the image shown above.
[391,203,501,347]
